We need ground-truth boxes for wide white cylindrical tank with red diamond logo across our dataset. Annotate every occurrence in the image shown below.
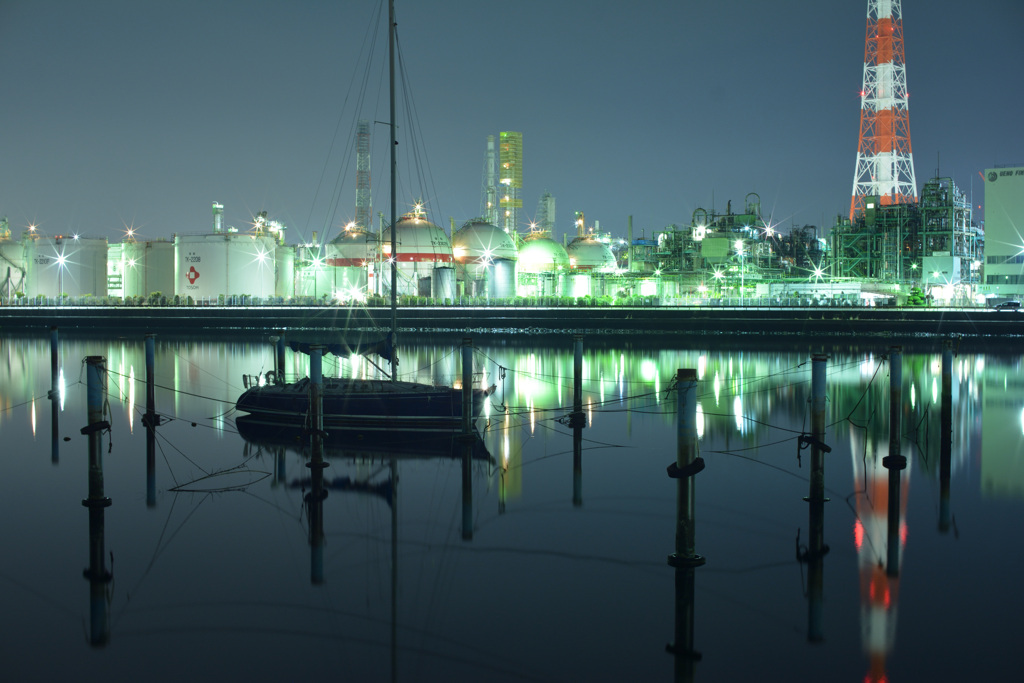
[174,232,278,300]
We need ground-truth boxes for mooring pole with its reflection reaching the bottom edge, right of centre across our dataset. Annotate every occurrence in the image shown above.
[666,370,705,681]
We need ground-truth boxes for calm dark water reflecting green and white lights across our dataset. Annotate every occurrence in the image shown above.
[0,336,1024,681]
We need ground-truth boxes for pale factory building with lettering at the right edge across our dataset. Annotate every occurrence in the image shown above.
[981,166,1024,298]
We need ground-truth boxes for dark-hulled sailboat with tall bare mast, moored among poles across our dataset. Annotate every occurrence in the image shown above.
[236,0,495,432]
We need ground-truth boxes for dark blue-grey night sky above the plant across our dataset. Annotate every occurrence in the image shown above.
[0,0,1024,243]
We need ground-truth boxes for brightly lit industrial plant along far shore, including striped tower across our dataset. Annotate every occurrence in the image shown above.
[0,0,1024,305]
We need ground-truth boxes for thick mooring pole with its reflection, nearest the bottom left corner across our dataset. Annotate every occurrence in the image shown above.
[82,355,112,647]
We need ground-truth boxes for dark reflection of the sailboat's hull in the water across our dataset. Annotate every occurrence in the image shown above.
[234,416,490,461]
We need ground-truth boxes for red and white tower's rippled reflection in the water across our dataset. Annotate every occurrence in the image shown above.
[851,434,909,681]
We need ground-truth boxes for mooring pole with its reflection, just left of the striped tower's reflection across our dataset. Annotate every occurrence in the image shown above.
[807,353,831,642]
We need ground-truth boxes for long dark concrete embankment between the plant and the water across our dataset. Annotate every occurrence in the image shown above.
[0,306,1024,339]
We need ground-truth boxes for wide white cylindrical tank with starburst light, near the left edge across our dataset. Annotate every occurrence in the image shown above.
[25,234,106,297]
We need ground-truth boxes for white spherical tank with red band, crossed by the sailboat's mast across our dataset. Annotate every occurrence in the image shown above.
[381,212,453,296]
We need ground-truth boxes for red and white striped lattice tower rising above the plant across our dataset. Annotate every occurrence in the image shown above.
[850,0,918,220]
